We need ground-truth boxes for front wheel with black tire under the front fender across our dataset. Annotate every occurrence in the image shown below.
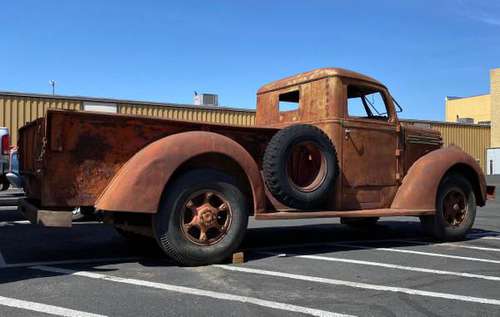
[420,174,476,241]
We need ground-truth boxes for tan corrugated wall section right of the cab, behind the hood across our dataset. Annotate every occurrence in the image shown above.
[403,121,491,171]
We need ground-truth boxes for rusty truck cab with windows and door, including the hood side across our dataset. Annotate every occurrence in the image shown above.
[256,68,442,210]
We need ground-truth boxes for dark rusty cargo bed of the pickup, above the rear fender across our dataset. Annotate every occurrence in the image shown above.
[18,110,276,210]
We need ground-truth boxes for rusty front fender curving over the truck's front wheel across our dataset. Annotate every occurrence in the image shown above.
[391,146,486,210]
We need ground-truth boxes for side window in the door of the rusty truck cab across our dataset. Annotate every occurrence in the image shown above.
[347,85,389,121]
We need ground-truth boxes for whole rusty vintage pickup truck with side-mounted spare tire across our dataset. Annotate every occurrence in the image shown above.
[18,68,494,265]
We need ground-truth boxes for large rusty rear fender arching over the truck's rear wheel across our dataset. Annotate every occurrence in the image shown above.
[95,131,265,213]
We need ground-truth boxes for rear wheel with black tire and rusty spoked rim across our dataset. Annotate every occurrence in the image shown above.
[153,169,249,266]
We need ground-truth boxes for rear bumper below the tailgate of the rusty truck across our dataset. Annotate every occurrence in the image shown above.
[17,199,73,228]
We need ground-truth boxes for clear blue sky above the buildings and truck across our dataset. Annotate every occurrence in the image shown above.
[0,0,500,120]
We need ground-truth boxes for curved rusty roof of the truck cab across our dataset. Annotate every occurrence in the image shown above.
[257,68,385,94]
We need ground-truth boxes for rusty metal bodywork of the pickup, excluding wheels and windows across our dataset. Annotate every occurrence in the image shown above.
[20,69,486,219]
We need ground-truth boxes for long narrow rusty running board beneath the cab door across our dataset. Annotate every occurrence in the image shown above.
[255,208,436,220]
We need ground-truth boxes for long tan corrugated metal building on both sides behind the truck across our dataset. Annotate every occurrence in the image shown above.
[0,92,490,169]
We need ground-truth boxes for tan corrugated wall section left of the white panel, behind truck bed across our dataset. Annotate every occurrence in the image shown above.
[0,95,82,144]
